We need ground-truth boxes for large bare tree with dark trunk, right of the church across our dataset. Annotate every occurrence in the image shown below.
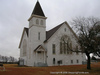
[69,17,100,69]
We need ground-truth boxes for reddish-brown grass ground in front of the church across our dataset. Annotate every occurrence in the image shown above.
[0,62,100,75]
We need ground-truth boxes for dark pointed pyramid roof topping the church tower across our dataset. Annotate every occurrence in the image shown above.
[32,1,45,17]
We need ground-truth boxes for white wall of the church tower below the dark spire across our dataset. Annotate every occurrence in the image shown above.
[27,17,46,66]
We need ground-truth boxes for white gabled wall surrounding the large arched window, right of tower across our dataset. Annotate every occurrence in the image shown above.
[47,24,83,66]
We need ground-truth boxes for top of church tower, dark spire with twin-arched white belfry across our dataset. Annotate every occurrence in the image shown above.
[28,1,47,28]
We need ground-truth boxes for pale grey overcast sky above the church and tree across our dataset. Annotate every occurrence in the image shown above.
[0,0,100,58]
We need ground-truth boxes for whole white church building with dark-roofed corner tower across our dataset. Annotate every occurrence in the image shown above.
[19,1,85,66]
